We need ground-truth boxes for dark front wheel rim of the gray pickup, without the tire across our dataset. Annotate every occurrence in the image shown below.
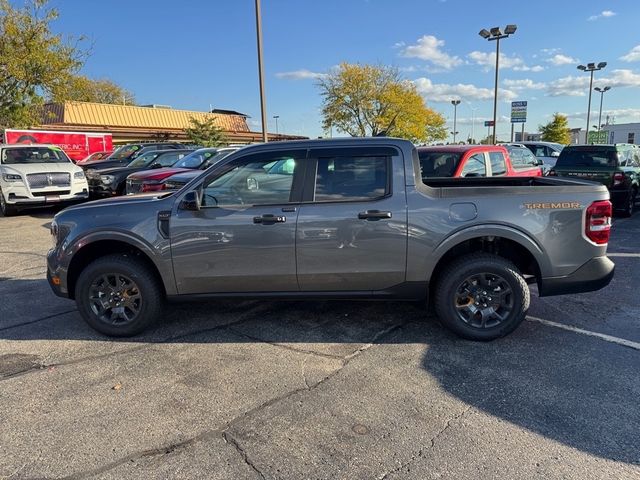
[89,273,142,325]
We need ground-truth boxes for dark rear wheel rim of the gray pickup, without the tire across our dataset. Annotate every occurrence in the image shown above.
[454,273,515,328]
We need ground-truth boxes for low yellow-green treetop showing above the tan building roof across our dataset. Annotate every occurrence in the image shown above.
[52,75,136,105]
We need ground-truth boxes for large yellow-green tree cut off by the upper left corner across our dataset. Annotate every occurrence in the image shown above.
[0,0,87,127]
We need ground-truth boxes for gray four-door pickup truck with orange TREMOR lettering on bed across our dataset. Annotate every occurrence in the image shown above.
[47,138,614,340]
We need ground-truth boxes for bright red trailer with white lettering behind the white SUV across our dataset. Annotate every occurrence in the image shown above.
[4,129,113,162]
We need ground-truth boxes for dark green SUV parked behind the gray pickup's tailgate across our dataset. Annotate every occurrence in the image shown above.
[549,144,640,216]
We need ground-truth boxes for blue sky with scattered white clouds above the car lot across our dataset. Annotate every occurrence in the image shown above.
[47,0,640,139]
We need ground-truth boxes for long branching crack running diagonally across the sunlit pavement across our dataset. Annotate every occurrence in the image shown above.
[53,319,406,480]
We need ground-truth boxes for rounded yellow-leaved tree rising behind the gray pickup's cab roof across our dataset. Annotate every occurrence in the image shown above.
[318,63,447,143]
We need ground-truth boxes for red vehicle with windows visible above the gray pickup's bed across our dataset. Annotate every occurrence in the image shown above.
[418,145,542,178]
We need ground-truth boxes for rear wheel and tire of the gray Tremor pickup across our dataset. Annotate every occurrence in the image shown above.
[434,253,531,341]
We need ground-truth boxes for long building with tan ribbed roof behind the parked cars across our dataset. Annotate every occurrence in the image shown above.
[38,102,306,143]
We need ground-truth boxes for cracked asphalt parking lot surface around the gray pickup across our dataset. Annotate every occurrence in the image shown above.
[0,211,640,479]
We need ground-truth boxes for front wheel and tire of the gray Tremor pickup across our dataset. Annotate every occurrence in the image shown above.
[75,254,164,337]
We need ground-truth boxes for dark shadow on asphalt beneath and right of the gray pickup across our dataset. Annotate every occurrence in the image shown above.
[0,279,640,464]
